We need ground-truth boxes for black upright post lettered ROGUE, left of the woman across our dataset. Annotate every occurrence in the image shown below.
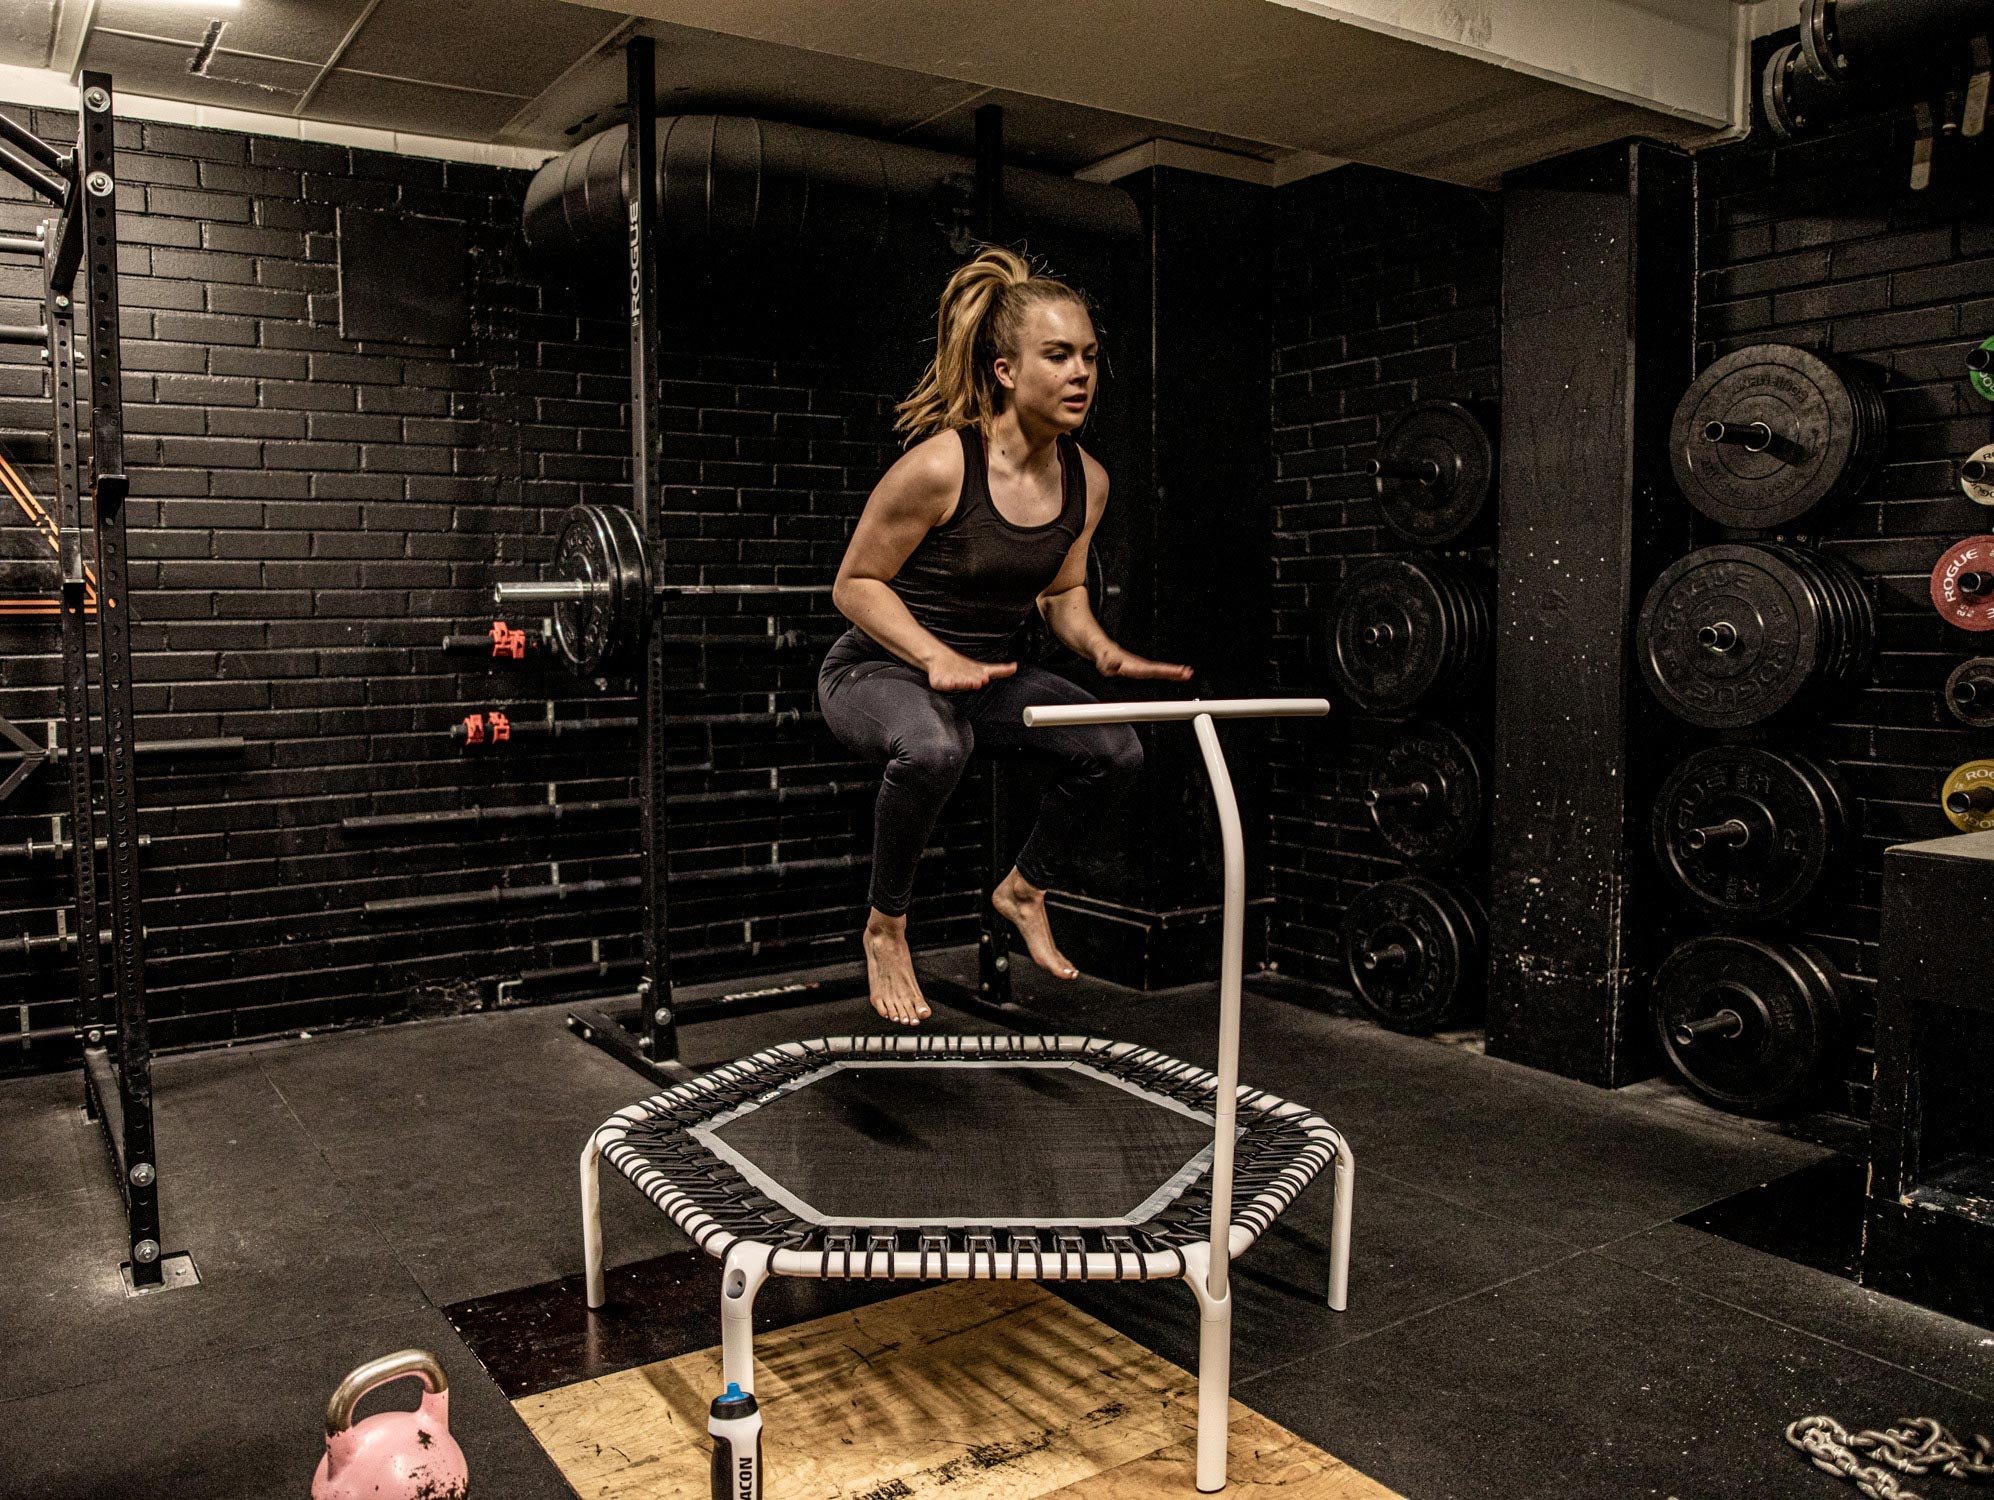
[624,36,678,1063]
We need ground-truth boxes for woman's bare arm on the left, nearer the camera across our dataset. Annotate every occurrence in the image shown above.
[831,433,1017,692]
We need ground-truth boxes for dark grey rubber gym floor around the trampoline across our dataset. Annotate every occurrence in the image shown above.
[0,953,1994,1500]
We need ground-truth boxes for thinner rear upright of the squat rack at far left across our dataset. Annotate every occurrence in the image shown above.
[42,243,104,1047]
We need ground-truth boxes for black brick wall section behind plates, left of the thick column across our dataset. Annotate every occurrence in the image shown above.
[1268,166,1501,987]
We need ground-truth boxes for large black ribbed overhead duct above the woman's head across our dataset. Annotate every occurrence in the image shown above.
[520,114,1143,269]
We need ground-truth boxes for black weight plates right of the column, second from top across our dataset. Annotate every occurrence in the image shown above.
[1635,543,1876,728]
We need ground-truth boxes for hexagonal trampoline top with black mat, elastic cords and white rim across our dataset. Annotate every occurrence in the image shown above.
[594,1035,1342,1281]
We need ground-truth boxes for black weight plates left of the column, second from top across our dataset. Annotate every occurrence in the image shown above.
[1326,557,1492,714]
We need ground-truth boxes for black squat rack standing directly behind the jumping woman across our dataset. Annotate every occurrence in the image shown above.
[546,36,1057,1083]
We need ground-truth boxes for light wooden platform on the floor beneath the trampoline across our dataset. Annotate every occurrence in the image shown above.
[514,1281,1398,1500]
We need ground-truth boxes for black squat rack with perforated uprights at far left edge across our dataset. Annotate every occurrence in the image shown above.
[0,72,166,1291]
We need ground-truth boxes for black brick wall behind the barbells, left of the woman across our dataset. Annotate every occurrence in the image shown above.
[0,112,981,1069]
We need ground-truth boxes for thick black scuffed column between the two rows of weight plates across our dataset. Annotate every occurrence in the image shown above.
[1488,142,1695,1087]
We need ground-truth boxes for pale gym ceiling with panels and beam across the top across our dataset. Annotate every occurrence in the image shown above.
[0,0,1791,186]
